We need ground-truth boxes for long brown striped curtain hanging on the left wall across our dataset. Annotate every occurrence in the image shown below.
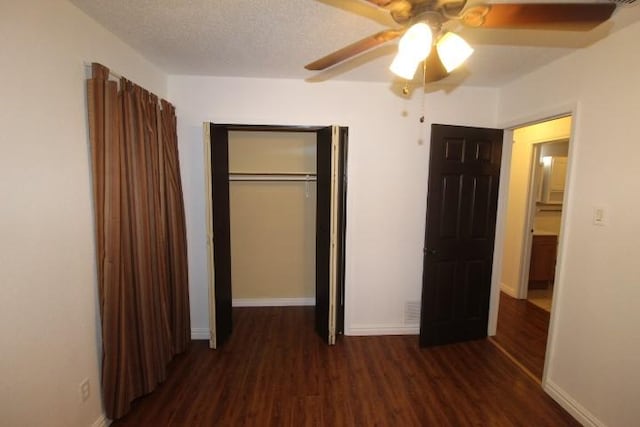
[87,64,191,419]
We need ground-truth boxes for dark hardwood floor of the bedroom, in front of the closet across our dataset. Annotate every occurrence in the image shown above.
[113,307,579,427]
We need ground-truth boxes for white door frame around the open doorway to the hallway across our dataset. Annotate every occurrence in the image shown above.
[487,103,580,391]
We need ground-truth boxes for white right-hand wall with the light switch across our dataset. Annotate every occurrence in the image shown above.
[499,18,640,426]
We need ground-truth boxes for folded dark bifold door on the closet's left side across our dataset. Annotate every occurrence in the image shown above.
[210,124,233,348]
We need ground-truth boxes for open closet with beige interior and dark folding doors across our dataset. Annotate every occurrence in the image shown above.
[204,123,348,348]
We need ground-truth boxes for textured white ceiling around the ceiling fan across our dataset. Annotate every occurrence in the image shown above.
[71,0,640,87]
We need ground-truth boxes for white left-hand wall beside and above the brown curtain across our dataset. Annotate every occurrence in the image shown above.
[0,0,166,427]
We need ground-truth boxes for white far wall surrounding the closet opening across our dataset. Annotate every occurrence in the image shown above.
[169,76,497,338]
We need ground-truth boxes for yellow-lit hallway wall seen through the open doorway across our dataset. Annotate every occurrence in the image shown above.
[501,117,571,296]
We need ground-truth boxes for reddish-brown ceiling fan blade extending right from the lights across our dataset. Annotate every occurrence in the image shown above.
[462,3,616,31]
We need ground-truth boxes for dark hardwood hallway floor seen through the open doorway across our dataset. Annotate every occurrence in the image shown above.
[493,292,549,380]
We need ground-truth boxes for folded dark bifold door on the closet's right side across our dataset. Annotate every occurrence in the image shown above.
[315,126,347,344]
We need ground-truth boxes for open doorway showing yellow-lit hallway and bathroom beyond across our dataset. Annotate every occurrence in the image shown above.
[493,116,571,382]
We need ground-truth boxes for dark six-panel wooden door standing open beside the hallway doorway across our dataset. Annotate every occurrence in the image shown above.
[420,125,503,346]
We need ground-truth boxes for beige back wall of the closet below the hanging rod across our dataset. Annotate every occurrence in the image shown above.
[229,182,316,299]
